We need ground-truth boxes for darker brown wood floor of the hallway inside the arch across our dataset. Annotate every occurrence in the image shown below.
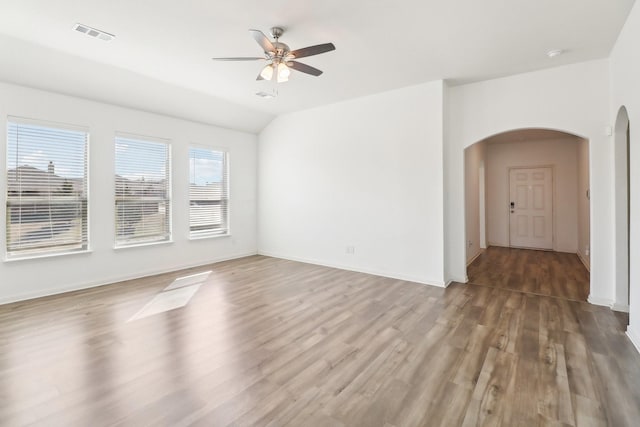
[467,246,589,301]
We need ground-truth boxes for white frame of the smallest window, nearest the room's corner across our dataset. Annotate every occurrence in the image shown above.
[187,144,231,240]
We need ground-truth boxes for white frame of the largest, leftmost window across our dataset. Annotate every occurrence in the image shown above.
[3,116,91,261]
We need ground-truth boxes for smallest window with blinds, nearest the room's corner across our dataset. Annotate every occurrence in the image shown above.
[189,147,229,238]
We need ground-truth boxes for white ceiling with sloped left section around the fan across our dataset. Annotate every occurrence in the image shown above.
[0,0,633,132]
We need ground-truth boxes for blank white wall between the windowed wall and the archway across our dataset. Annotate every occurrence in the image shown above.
[258,82,444,285]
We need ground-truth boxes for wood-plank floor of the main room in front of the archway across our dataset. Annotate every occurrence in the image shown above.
[0,256,640,427]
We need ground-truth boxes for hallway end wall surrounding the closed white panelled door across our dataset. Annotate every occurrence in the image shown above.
[486,138,579,253]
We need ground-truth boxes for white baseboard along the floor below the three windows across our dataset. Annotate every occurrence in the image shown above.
[0,252,257,305]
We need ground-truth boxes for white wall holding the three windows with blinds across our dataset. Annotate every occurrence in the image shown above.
[0,84,257,303]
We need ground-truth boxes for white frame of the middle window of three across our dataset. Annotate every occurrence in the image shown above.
[113,132,173,249]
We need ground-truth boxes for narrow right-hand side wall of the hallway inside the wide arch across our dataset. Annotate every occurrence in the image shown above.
[578,139,591,270]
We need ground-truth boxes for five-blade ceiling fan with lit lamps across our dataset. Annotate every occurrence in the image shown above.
[212,27,336,83]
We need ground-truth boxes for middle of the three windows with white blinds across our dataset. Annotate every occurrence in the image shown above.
[115,136,171,247]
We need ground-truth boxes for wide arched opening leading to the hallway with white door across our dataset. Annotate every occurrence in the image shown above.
[464,128,590,301]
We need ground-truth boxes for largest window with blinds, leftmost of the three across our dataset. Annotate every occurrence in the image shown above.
[6,118,89,259]
